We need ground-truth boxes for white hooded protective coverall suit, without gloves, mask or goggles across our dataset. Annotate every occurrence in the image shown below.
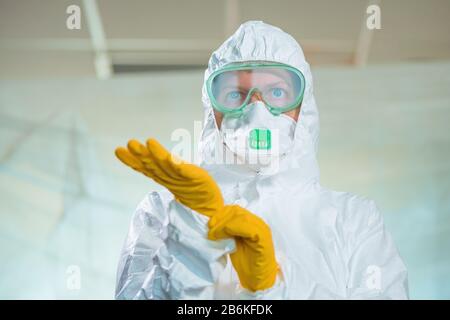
[116,21,408,299]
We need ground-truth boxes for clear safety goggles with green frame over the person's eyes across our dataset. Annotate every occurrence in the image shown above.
[206,62,305,115]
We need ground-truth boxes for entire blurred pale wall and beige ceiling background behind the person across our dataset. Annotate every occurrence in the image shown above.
[0,0,450,299]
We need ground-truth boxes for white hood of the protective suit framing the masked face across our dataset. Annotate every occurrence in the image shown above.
[198,21,319,190]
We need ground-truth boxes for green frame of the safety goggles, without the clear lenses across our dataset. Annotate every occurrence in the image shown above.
[206,62,305,116]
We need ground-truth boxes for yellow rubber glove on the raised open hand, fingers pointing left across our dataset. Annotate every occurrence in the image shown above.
[116,139,224,217]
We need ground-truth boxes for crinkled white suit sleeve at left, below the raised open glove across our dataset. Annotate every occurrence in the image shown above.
[115,192,234,300]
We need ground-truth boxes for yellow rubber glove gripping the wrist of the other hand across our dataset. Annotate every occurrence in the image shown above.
[208,205,278,291]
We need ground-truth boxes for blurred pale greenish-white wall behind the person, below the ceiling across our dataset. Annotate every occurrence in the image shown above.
[0,63,450,299]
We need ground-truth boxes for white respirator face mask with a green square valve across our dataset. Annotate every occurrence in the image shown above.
[220,101,297,166]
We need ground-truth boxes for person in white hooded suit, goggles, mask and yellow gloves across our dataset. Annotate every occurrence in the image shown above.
[115,21,408,299]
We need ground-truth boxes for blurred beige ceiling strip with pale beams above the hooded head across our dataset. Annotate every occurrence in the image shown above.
[0,0,450,78]
